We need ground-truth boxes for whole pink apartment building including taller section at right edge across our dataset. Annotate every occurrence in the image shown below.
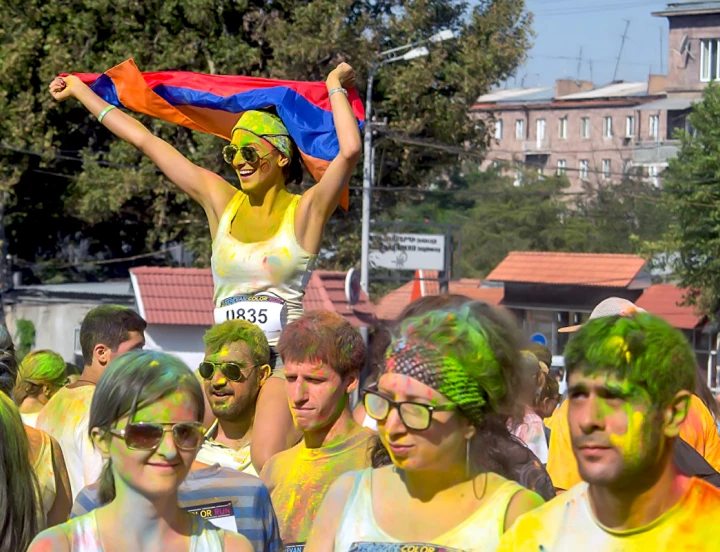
[472,0,720,191]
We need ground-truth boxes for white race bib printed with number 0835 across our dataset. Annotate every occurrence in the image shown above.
[215,293,287,341]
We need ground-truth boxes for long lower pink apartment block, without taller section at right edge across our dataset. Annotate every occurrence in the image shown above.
[473,76,666,191]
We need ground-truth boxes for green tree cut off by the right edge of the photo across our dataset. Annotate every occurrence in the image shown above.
[662,83,720,317]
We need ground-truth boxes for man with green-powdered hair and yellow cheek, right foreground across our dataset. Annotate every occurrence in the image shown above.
[497,312,720,552]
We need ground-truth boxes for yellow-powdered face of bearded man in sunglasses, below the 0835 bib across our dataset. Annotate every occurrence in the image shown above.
[203,342,269,421]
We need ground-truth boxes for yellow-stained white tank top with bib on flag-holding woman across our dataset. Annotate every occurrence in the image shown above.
[211,191,317,345]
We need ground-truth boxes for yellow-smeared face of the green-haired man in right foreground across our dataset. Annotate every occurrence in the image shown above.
[568,370,668,487]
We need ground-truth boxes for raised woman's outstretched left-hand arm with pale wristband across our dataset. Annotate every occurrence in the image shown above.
[50,75,237,226]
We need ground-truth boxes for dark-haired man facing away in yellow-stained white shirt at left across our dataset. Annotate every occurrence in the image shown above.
[37,305,147,500]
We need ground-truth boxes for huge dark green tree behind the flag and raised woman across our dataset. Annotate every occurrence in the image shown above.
[0,0,530,279]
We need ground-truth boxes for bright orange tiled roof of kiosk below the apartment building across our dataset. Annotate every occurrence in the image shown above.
[486,251,645,288]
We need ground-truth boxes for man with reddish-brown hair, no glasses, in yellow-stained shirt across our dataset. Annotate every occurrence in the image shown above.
[260,311,373,547]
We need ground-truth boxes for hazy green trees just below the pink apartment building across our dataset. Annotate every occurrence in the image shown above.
[393,163,667,278]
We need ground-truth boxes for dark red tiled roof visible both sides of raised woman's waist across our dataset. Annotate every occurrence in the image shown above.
[130,266,374,326]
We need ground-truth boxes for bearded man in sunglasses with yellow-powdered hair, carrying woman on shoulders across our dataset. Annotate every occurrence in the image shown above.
[196,320,270,475]
